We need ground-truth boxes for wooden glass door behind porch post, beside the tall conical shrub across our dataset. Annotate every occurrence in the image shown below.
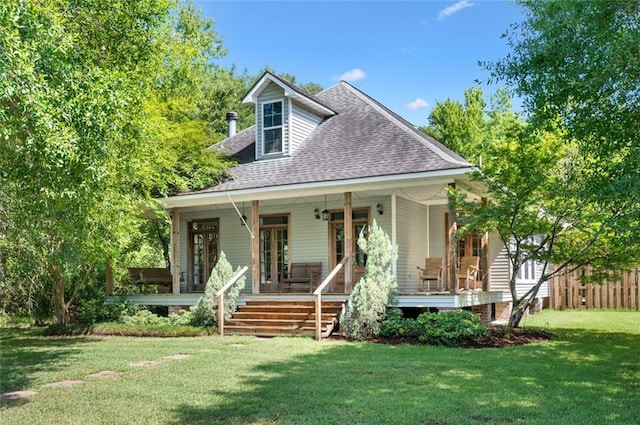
[329,208,369,293]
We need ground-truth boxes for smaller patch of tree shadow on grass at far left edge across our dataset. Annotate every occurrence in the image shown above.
[0,328,96,393]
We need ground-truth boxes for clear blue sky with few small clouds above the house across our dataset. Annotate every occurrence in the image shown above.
[194,0,523,125]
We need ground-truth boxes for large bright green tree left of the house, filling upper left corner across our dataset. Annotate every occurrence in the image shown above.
[0,0,242,325]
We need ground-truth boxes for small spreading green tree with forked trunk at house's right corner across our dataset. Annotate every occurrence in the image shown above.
[455,117,639,327]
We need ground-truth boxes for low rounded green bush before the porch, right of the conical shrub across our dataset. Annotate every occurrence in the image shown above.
[417,310,488,347]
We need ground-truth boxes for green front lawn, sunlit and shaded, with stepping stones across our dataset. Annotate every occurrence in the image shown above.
[0,311,640,424]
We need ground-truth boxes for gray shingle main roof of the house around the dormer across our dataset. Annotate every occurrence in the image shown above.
[191,82,470,193]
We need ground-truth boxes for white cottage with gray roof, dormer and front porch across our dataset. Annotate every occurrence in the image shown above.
[112,72,547,336]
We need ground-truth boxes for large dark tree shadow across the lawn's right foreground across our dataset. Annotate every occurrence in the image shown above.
[168,330,640,425]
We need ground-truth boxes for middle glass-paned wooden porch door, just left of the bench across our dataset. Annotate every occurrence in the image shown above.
[260,214,289,292]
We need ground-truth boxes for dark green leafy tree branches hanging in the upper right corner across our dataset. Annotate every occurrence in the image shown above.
[484,0,640,260]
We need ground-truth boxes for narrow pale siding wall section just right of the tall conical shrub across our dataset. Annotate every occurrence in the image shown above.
[396,197,428,292]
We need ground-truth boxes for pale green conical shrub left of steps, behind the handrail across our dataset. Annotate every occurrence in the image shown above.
[191,252,246,327]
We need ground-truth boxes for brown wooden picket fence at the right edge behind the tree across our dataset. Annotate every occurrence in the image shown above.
[549,269,640,310]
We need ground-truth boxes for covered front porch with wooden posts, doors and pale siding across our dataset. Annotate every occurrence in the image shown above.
[107,172,489,302]
